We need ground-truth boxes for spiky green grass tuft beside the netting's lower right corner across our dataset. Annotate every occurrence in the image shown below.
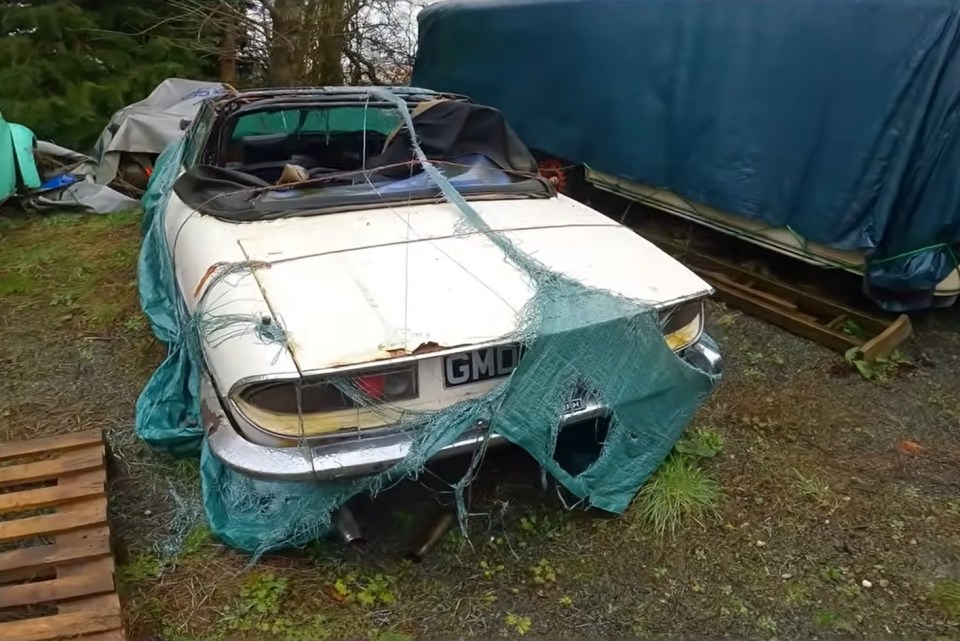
[637,454,720,536]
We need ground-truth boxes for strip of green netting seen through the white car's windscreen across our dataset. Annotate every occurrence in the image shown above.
[233,107,401,140]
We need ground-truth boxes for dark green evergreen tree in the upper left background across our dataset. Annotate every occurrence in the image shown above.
[0,0,217,151]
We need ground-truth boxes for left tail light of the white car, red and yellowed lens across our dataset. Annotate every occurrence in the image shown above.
[234,364,419,437]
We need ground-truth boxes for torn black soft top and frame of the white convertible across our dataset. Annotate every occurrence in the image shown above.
[173,87,556,222]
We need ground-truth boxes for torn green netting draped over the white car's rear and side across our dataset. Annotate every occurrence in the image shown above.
[136,89,716,557]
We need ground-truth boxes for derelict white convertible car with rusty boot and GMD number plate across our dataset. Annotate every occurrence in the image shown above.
[164,88,721,481]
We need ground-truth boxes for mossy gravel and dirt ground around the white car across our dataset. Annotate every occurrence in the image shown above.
[0,208,960,641]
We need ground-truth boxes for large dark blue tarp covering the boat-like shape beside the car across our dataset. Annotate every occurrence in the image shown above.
[413,0,960,306]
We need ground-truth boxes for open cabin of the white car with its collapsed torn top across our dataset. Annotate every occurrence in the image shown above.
[174,102,555,221]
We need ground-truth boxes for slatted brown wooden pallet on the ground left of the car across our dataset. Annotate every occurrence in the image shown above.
[0,430,125,641]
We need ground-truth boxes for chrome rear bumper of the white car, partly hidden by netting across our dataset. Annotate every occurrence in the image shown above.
[206,334,722,481]
